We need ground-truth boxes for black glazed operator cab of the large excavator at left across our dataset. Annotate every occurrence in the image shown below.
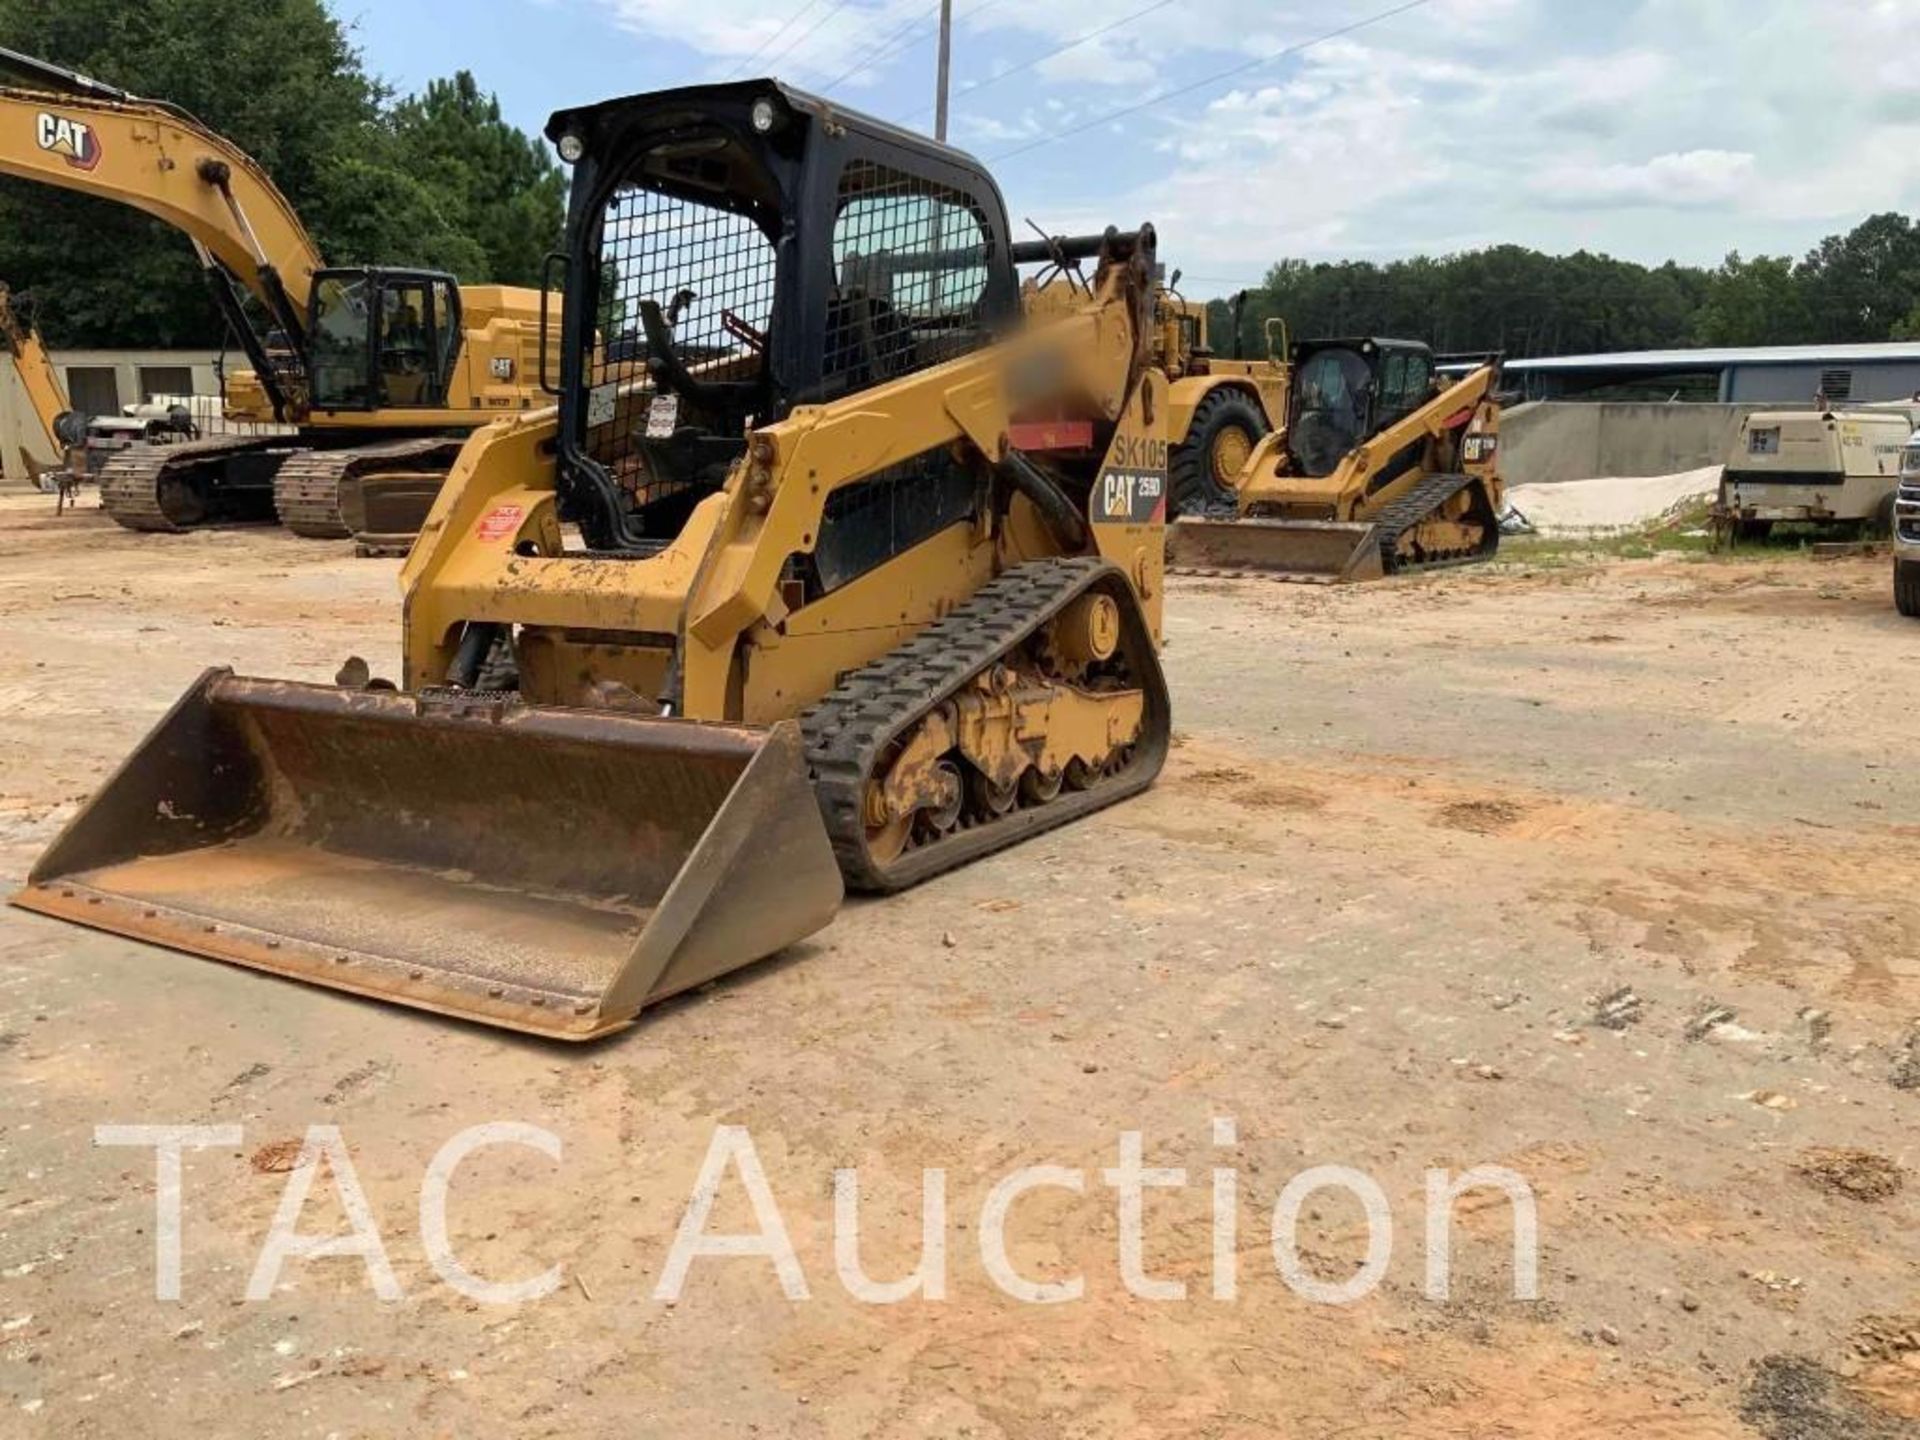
[307,269,461,411]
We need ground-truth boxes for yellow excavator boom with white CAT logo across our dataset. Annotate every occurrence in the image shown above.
[0,63,323,359]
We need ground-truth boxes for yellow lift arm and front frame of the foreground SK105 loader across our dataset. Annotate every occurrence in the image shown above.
[401,247,1165,720]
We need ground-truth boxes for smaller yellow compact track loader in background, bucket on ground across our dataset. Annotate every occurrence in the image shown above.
[1169,338,1505,582]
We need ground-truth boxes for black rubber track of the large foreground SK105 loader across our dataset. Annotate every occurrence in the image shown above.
[801,557,1171,891]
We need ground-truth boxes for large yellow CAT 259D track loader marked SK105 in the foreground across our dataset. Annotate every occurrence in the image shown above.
[15,81,1171,1039]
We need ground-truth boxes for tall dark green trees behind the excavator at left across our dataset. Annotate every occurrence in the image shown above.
[0,0,566,348]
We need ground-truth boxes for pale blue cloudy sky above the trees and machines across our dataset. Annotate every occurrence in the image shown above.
[332,0,1920,294]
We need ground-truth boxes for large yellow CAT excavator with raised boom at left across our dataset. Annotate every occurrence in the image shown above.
[0,50,545,543]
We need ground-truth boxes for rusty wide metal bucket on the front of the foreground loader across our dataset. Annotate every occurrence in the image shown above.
[13,670,841,1041]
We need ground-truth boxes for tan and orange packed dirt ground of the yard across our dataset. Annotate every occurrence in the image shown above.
[0,497,1920,1440]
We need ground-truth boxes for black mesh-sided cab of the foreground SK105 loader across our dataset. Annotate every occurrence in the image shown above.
[547,81,1020,551]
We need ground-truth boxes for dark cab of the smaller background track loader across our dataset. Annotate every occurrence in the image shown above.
[1286,338,1434,478]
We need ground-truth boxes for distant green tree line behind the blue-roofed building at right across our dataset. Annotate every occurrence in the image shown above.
[1213,213,1920,359]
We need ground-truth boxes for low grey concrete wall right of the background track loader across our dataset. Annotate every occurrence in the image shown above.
[1500,399,1780,486]
